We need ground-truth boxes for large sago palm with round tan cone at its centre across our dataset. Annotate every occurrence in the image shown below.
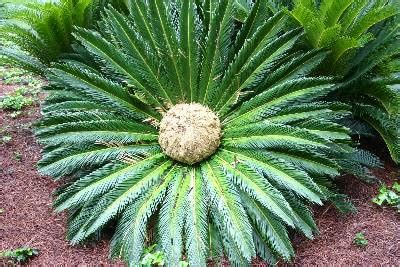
[37,0,377,266]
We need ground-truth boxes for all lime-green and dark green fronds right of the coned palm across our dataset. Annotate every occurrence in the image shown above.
[290,0,400,163]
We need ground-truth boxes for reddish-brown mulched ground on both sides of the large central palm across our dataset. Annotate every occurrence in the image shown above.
[0,79,400,266]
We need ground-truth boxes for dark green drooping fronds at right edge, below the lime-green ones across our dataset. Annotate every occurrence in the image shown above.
[335,16,400,163]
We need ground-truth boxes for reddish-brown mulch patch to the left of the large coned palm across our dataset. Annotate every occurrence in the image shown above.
[0,85,122,266]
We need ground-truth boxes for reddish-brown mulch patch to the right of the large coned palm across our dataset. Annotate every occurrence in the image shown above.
[286,166,400,266]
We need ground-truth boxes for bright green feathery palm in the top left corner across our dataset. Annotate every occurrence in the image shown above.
[0,0,126,75]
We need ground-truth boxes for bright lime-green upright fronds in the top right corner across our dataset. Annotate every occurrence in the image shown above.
[290,0,400,74]
